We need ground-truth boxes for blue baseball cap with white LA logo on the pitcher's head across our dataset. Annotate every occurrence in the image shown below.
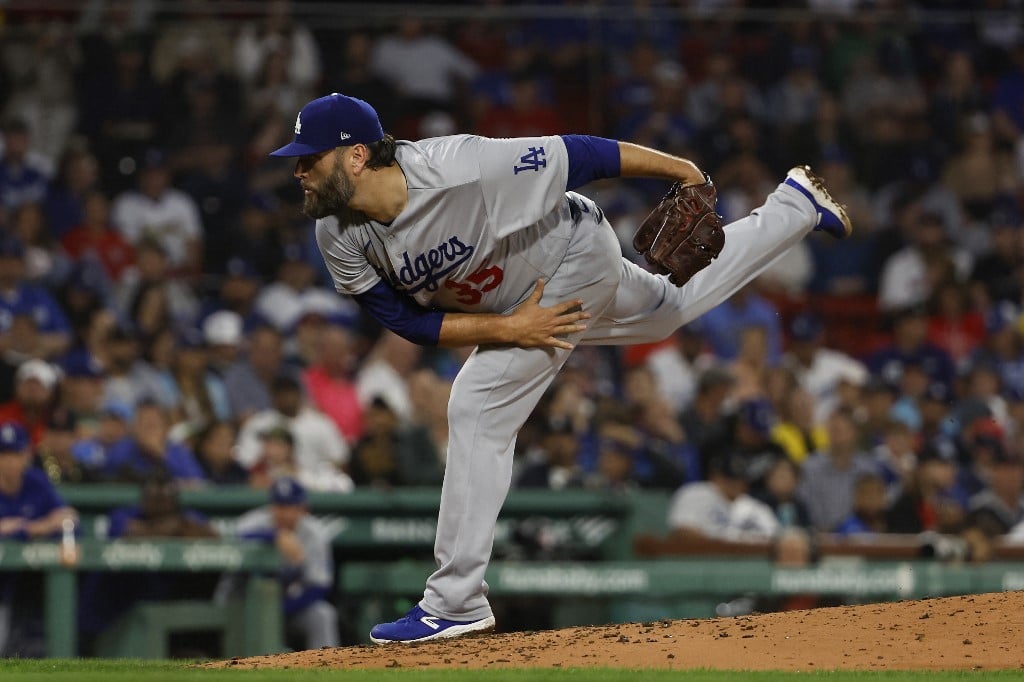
[270,92,384,157]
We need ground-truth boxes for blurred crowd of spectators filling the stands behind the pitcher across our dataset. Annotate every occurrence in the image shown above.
[0,0,1024,569]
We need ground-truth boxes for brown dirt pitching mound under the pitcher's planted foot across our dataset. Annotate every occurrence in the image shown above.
[211,592,1024,671]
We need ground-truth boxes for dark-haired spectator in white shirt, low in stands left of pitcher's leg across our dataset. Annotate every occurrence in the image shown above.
[236,375,351,487]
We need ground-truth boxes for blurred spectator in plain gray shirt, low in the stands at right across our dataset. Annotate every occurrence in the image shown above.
[798,409,876,532]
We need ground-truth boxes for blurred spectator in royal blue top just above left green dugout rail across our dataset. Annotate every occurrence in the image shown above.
[103,402,206,486]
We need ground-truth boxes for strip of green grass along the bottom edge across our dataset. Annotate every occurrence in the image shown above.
[0,659,1024,682]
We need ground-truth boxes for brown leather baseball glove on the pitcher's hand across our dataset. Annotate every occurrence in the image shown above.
[633,173,725,287]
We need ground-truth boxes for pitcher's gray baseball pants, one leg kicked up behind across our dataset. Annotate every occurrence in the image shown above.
[420,184,817,621]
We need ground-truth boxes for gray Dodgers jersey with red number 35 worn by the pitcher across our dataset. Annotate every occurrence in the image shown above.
[316,135,600,312]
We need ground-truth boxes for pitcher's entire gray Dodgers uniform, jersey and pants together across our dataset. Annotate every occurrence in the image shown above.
[307,129,816,621]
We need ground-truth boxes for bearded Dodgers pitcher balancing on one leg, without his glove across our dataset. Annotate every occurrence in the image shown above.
[272,92,850,643]
